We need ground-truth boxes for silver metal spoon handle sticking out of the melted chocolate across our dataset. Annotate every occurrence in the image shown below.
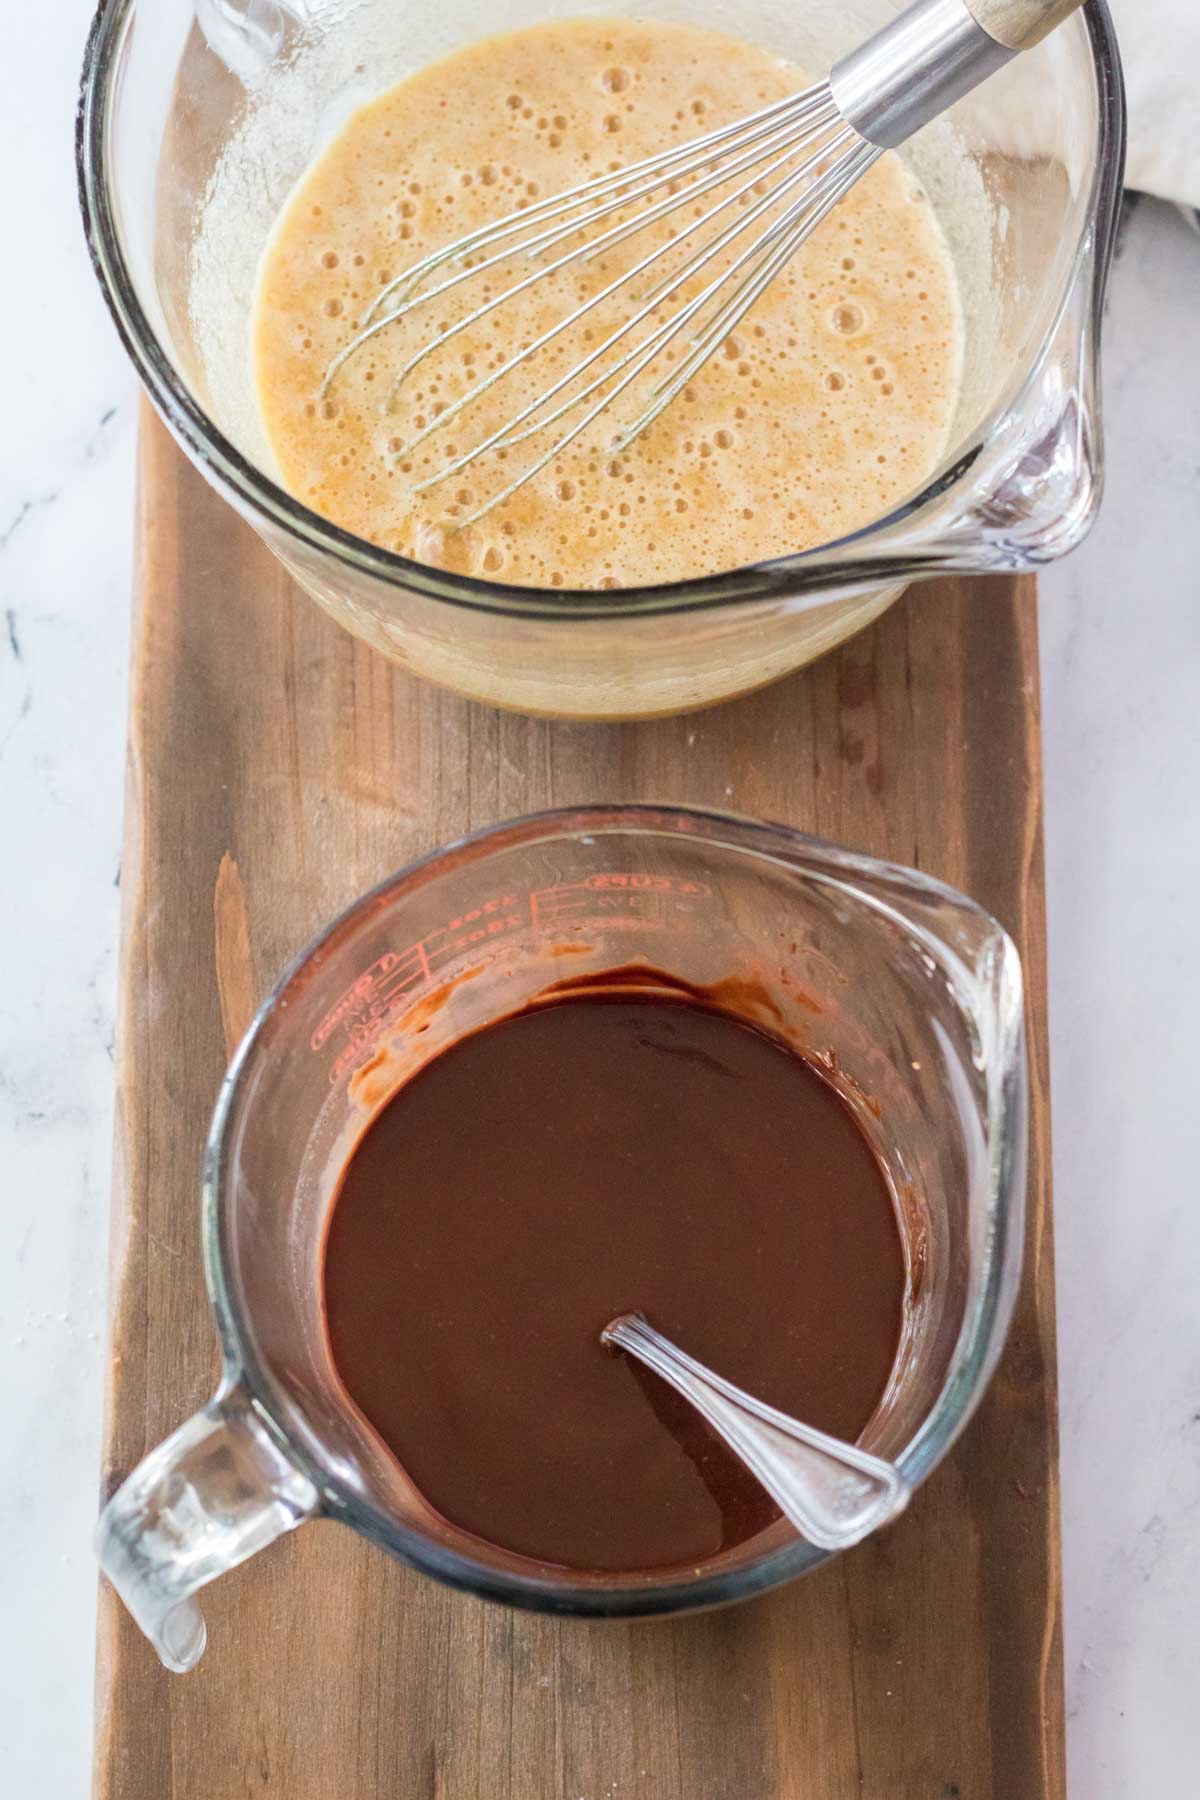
[601,1312,912,1550]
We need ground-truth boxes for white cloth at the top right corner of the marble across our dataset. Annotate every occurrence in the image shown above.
[1108,0,1200,209]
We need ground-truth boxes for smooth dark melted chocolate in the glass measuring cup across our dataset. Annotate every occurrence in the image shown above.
[324,990,905,1573]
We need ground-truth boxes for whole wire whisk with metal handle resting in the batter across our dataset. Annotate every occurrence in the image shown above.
[320,0,1081,527]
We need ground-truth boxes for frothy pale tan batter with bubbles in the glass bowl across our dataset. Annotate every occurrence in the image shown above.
[254,20,963,589]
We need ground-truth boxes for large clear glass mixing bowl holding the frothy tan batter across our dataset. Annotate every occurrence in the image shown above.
[77,0,1124,716]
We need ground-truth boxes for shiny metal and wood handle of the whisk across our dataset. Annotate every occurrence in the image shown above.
[829,0,1081,149]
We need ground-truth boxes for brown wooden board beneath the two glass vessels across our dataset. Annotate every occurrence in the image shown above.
[95,412,1063,1800]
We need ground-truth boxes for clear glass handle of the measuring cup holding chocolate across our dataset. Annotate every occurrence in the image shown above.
[95,1384,320,1674]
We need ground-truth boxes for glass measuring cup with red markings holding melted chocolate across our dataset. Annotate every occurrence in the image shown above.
[97,806,1025,1670]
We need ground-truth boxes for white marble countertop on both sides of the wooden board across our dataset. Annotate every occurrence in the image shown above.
[0,0,1200,1800]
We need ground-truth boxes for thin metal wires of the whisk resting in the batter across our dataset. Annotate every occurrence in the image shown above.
[320,83,880,527]
